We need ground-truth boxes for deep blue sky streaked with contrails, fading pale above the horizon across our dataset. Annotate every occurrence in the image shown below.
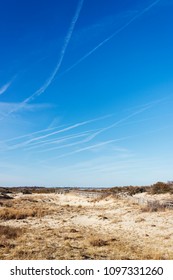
[0,0,173,187]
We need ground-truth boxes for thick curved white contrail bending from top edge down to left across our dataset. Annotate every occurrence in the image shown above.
[2,0,84,116]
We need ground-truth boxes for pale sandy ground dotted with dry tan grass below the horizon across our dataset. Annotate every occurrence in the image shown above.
[0,192,173,259]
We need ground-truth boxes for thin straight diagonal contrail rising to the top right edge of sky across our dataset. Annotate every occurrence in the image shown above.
[59,0,161,77]
